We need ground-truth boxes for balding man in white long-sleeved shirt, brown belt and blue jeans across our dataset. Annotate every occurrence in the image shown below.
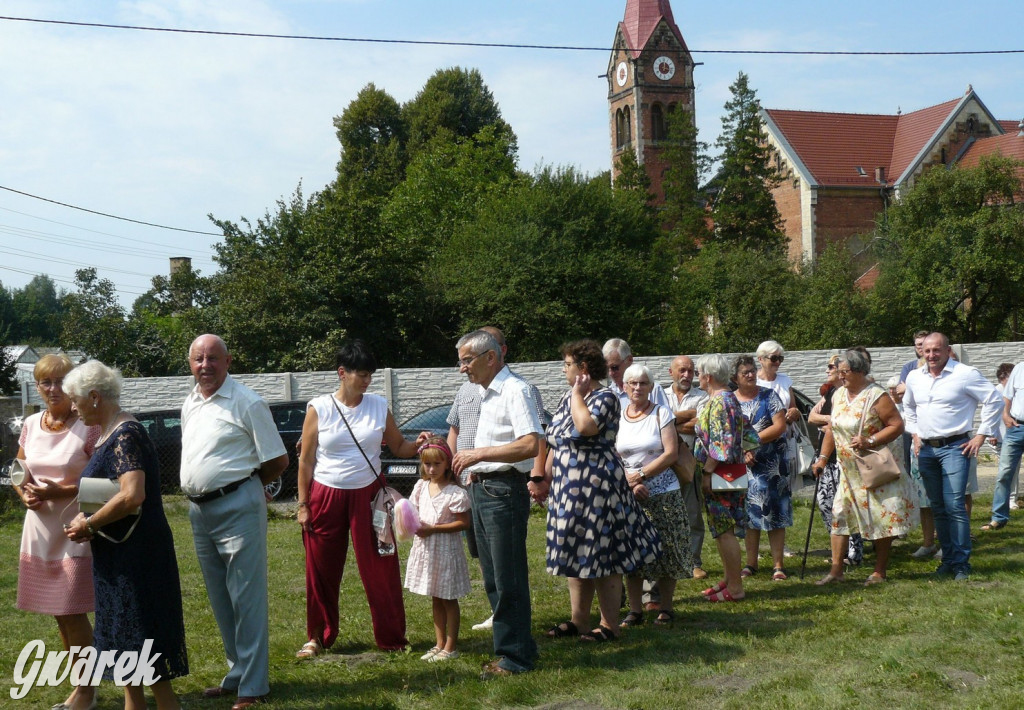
[903,333,1001,580]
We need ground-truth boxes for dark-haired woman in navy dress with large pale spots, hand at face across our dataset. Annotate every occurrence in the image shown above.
[547,340,660,641]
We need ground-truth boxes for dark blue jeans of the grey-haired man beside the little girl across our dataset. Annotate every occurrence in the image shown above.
[469,473,537,673]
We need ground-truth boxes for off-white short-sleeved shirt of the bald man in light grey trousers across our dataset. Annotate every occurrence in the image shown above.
[181,375,287,496]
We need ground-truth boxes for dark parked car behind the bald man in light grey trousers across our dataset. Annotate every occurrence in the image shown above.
[135,400,306,499]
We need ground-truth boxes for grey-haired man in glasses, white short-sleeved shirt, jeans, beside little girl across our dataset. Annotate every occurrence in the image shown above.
[452,330,542,678]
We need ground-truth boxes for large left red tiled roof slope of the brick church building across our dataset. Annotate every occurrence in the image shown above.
[765,109,899,186]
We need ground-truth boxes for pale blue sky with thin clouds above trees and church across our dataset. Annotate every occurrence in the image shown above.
[0,0,1024,307]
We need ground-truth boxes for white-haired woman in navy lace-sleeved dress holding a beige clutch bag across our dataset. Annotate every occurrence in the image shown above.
[63,361,188,710]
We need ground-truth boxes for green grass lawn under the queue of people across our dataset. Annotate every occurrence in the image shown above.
[0,497,1024,710]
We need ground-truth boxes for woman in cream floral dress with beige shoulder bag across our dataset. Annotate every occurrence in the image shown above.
[814,350,919,585]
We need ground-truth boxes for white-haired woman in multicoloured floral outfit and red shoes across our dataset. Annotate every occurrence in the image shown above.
[693,354,760,601]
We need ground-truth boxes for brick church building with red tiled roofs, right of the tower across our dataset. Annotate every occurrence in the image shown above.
[761,86,1024,261]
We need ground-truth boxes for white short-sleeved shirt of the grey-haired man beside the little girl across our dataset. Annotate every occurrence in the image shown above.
[470,366,544,472]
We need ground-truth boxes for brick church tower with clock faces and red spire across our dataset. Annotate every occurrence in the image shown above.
[607,0,696,204]
